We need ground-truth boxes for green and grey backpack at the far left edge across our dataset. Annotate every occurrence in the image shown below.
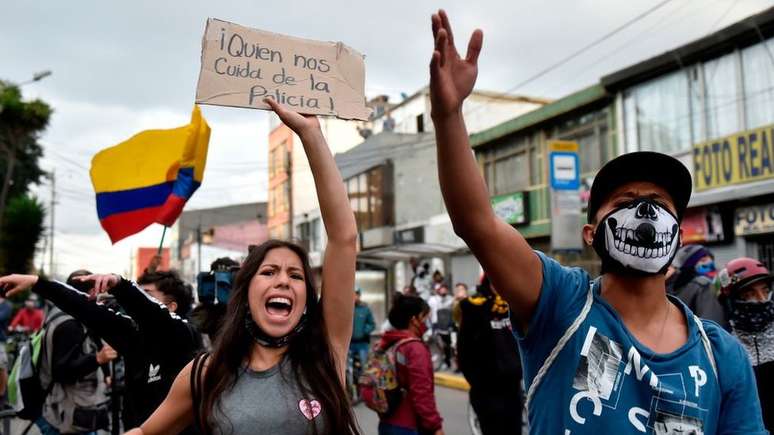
[8,312,65,421]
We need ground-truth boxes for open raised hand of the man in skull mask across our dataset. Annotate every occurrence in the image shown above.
[430,9,484,118]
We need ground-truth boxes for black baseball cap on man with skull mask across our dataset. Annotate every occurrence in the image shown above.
[586,151,693,223]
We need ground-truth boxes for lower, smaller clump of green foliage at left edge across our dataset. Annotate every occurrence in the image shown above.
[0,195,45,275]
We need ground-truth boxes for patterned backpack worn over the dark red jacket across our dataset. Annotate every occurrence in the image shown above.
[357,337,420,417]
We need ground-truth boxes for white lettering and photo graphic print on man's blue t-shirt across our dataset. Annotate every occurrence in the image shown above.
[566,326,708,435]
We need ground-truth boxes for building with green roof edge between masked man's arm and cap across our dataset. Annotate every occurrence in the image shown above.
[471,85,618,272]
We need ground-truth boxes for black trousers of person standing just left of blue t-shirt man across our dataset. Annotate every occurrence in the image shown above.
[470,381,522,435]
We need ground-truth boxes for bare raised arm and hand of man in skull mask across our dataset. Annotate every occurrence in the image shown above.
[430,10,543,330]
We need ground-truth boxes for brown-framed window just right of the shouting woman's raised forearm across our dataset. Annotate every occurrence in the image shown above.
[345,165,393,231]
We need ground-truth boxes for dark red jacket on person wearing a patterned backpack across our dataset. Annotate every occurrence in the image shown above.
[379,331,443,433]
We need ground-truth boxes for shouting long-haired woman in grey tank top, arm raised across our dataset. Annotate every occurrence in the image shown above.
[105,100,358,435]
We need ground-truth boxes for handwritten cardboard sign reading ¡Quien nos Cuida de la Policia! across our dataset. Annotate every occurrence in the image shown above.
[196,18,371,120]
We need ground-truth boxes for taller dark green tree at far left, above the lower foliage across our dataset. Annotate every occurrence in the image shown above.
[0,80,52,228]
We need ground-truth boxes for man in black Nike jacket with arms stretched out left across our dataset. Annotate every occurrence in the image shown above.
[0,272,202,433]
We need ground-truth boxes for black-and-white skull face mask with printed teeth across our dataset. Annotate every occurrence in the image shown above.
[594,198,680,275]
